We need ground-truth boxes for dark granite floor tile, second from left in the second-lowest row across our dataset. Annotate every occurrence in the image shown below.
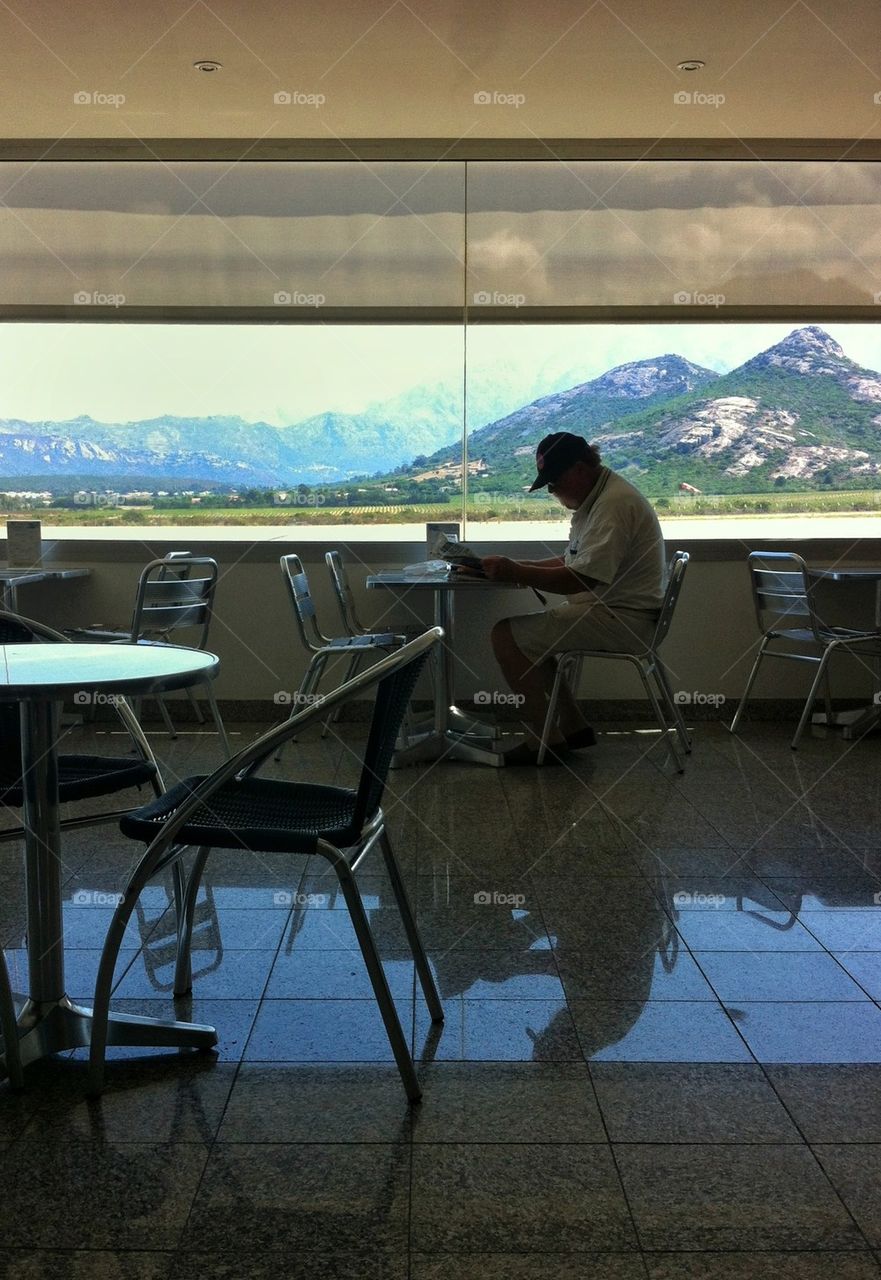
[182,1143,410,1262]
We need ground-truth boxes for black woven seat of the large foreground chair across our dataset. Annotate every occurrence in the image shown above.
[119,777,361,854]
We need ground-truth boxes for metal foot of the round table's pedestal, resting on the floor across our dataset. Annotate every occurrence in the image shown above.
[0,996,218,1075]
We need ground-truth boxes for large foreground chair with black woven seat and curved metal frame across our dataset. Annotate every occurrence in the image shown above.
[90,627,443,1102]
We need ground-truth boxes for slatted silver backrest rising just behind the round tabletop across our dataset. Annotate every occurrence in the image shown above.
[132,553,218,649]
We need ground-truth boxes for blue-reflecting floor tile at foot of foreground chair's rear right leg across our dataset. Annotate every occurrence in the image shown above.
[415,997,581,1062]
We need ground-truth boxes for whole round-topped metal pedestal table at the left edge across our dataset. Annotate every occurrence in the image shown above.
[0,644,219,1066]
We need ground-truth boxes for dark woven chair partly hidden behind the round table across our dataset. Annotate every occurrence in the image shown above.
[0,612,165,1088]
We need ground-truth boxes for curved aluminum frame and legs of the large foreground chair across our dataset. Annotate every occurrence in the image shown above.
[90,627,443,1102]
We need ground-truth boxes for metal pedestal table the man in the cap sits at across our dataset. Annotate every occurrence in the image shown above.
[368,568,516,768]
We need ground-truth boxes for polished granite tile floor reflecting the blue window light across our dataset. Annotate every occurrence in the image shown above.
[0,724,881,1280]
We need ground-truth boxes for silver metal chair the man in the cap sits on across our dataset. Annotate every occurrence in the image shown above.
[538,552,691,773]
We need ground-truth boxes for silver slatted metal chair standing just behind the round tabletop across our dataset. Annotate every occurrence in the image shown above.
[67,552,229,755]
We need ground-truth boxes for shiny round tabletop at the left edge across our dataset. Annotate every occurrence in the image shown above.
[0,644,220,703]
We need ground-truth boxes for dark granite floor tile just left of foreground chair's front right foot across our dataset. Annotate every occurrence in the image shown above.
[218,1062,411,1143]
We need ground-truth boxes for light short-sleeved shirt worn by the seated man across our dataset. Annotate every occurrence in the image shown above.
[563,467,667,609]
